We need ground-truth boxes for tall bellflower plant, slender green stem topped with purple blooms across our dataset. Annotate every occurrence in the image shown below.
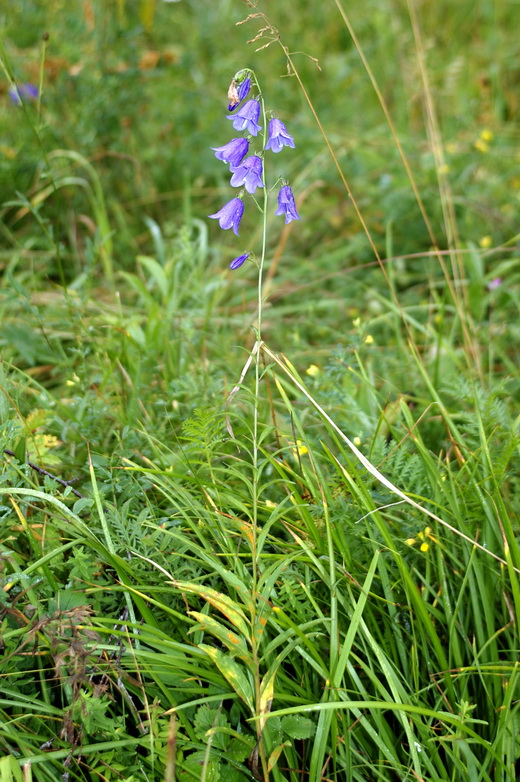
[210,69,300,779]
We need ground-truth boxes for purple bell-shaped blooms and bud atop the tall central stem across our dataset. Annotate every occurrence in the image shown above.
[209,71,300,269]
